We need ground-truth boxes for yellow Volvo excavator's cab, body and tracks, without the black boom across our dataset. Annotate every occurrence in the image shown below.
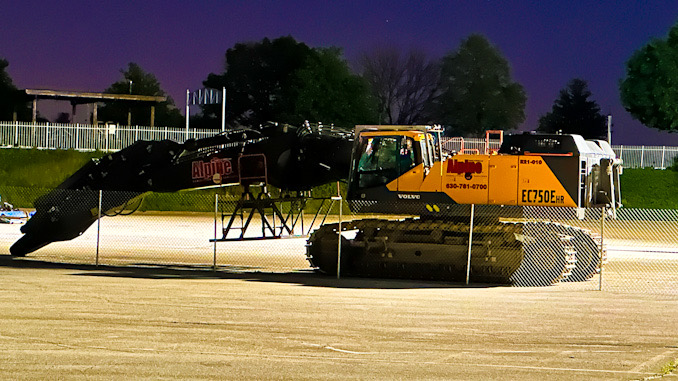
[307,126,622,286]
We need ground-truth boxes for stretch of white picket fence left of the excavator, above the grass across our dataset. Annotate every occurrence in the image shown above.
[0,122,217,151]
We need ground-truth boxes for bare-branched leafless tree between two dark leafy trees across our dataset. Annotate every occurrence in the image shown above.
[359,47,440,124]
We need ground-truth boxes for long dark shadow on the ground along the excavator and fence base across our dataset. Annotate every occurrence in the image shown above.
[0,255,505,289]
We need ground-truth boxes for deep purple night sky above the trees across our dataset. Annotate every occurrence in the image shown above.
[0,0,678,145]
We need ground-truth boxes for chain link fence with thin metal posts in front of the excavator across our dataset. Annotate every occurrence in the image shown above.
[0,187,678,297]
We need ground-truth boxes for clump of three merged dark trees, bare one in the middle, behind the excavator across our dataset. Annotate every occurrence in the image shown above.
[202,35,526,135]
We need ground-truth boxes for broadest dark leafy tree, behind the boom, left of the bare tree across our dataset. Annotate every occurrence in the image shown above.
[203,36,380,126]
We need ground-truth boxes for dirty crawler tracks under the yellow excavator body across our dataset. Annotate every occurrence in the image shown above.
[306,218,600,286]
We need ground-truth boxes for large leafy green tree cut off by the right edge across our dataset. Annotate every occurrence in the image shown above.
[619,23,678,132]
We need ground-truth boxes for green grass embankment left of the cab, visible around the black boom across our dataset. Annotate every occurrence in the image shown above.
[0,148,346,212]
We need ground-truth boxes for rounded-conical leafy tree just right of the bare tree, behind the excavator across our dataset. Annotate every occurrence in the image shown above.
[434,34,527,136]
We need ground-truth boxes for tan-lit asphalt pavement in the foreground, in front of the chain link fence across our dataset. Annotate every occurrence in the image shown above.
[0,255,678,380]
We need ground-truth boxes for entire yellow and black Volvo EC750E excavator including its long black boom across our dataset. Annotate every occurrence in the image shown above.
[10,123,621,286]
